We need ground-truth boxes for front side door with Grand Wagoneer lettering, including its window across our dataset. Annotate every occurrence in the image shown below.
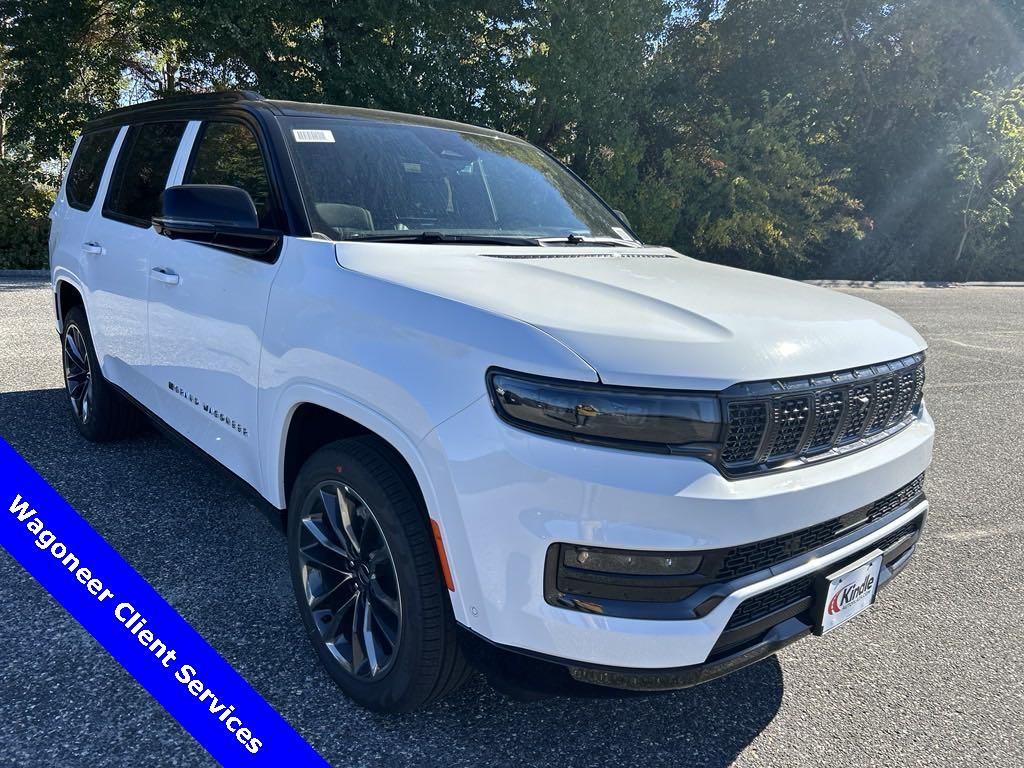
[148,119,287,486]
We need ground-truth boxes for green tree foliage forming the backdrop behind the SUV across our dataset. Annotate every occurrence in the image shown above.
[0,0,1024,280]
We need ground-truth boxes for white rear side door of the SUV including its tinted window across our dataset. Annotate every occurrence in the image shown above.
[85,121,187,406]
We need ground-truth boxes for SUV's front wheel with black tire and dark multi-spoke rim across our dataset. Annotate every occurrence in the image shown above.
[288,436,469,713]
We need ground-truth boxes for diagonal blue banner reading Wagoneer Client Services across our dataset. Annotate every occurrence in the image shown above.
[0,439,327,767]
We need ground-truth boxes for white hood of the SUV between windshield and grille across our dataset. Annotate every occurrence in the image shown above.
[337,243,926,389]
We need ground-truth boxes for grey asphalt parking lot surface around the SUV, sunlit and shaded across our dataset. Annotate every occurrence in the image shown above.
[0,275,1024,768]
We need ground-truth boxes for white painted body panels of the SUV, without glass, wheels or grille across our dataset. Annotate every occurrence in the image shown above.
[51,111,934,668]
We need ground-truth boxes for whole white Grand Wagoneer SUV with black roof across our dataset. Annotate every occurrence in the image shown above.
[50,92,934,711]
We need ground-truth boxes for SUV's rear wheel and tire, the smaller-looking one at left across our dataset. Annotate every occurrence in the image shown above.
[60,306,143,442]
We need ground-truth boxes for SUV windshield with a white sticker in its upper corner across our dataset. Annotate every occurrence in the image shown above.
[285,118,635,242]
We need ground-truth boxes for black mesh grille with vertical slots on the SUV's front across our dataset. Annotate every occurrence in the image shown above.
[719,353,925,475]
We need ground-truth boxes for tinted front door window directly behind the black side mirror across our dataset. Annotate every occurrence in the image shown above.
[185,123,271,226]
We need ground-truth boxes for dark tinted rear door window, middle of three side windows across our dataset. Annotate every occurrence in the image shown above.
[103,123,185,226]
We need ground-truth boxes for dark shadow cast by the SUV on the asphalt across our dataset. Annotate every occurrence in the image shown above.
[0,389,783,768]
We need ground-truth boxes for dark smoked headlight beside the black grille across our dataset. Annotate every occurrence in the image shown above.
[487,371,721,453]
